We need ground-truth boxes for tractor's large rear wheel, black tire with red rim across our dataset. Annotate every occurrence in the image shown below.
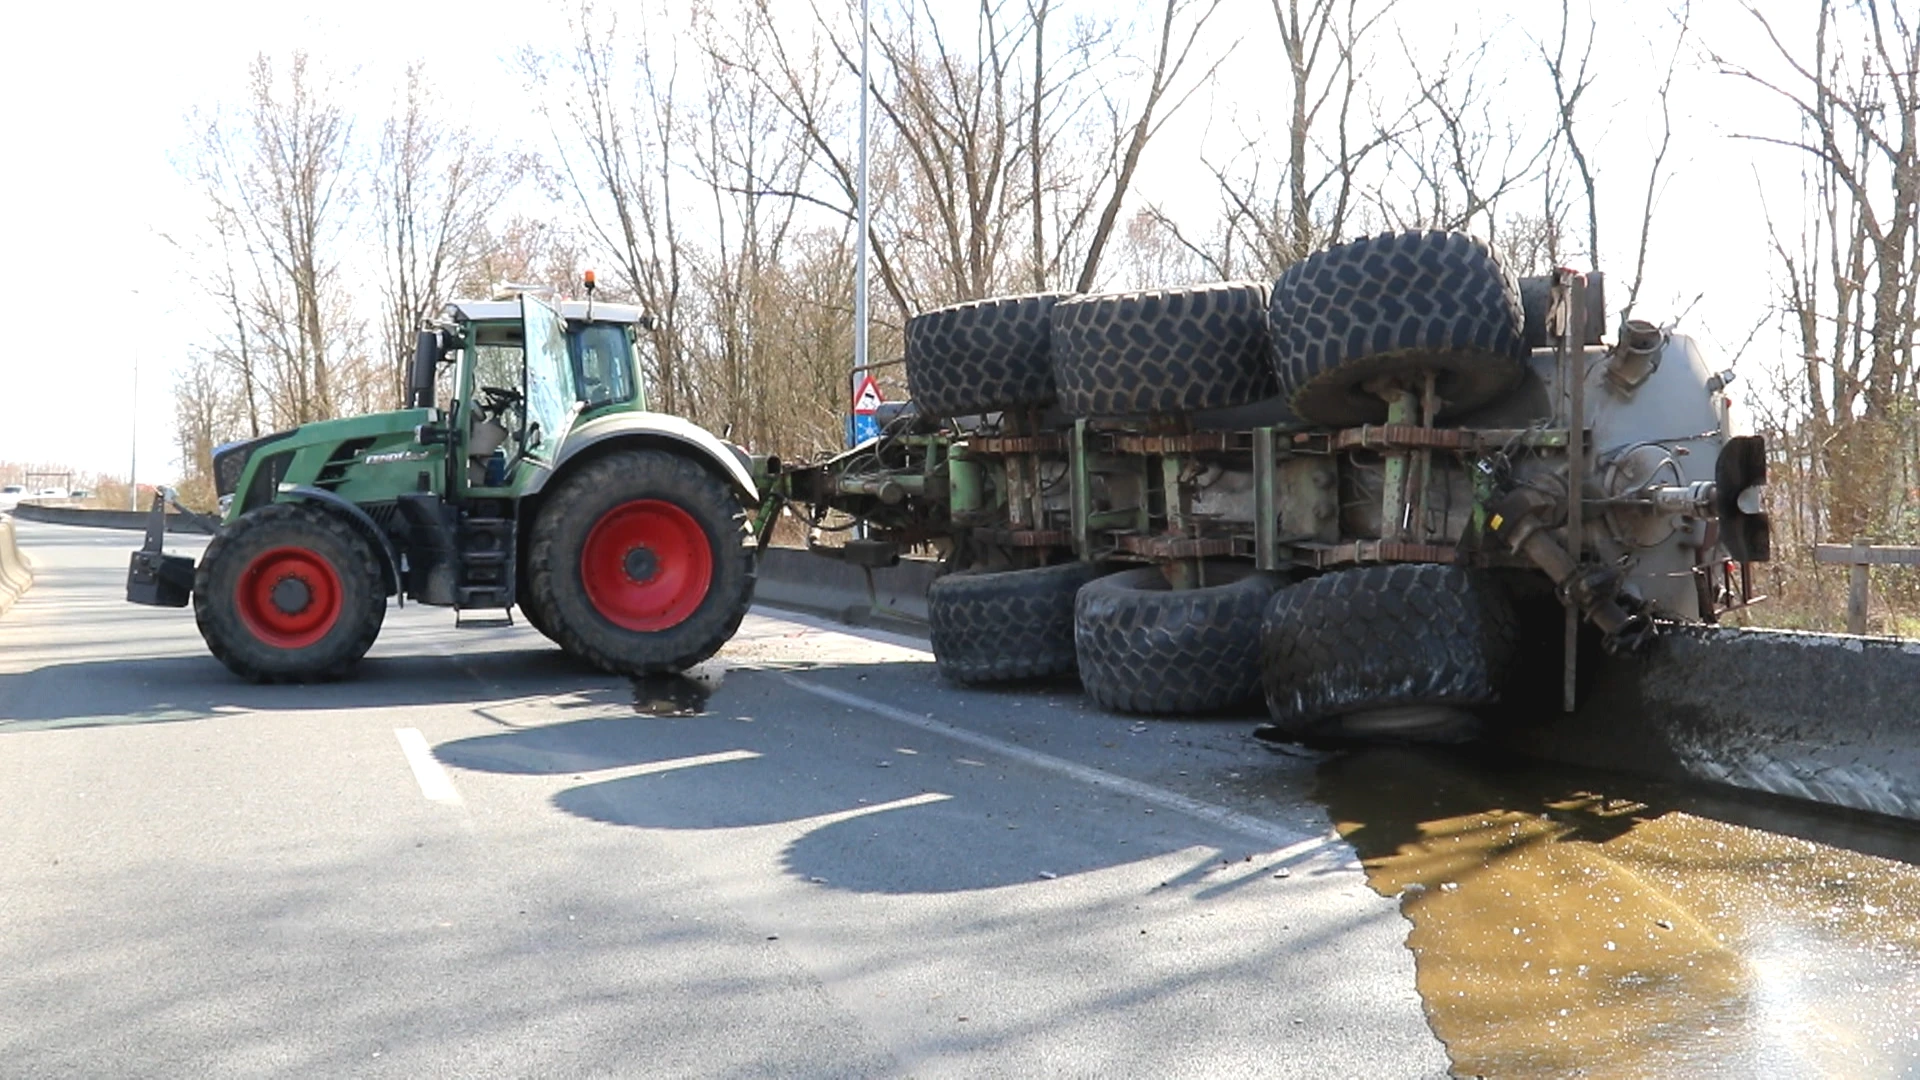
[522,450,755,675]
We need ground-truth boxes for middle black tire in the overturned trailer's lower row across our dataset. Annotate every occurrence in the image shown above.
[1073,563,1284,713]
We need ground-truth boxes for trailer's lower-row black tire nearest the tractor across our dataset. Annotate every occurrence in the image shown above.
[927,563,1100,682]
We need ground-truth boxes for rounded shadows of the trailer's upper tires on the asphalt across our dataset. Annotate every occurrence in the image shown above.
[434,663,1305,894]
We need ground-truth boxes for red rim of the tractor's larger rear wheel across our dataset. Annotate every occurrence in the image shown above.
[580,500,714,632]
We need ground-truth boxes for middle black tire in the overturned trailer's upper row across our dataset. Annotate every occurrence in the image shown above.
[1052,282,1275,417]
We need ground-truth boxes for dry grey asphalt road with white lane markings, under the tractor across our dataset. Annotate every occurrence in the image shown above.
[0,523,1443,1078]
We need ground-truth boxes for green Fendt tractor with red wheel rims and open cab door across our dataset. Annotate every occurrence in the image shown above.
[127,279,768,682]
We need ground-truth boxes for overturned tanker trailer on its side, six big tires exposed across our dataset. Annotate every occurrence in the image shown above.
[762,233,1797,760]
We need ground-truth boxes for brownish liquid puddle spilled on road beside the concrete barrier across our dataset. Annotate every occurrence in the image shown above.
[1319,748,1920,1078]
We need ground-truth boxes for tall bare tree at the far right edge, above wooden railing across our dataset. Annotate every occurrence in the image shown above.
[1715,0,1920,553]
